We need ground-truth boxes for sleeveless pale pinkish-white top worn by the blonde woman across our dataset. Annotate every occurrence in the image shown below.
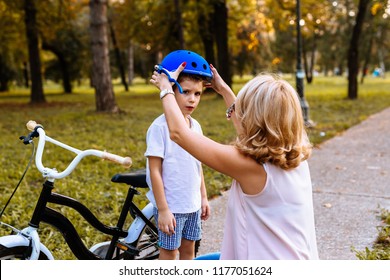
[221,161,318,260]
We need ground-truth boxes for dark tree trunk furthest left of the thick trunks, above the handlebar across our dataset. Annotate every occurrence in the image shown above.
[24,0,46,103]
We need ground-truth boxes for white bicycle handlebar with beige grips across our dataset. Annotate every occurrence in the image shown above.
[26,121,132,179]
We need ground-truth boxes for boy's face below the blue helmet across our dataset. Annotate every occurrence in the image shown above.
[175,79,203,117]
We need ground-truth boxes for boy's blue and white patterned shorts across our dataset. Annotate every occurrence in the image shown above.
[153,208,202,250]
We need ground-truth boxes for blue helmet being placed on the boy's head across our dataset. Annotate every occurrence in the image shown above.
[160,50,213,80]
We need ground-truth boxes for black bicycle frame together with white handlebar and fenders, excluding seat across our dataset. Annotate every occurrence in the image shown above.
[2,119,157,260]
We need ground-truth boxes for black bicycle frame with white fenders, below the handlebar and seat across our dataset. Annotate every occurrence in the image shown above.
[1,176,157,260]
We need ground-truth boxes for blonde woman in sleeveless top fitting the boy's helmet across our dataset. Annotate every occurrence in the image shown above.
[151,62,318,260]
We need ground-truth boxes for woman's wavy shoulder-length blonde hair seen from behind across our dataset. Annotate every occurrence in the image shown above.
[235,74,312,170]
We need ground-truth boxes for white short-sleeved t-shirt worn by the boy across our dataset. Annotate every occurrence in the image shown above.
[145,114,202,213]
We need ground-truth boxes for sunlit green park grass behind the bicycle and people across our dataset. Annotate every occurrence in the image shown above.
[0,75,390,259]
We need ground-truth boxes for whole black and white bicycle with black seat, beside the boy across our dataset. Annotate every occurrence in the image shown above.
[0,121,159,260]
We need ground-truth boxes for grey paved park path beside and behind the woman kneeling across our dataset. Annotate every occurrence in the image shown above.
[199,108,390,260]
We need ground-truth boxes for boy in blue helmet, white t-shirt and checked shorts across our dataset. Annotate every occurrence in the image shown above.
[145,50,212,260]
